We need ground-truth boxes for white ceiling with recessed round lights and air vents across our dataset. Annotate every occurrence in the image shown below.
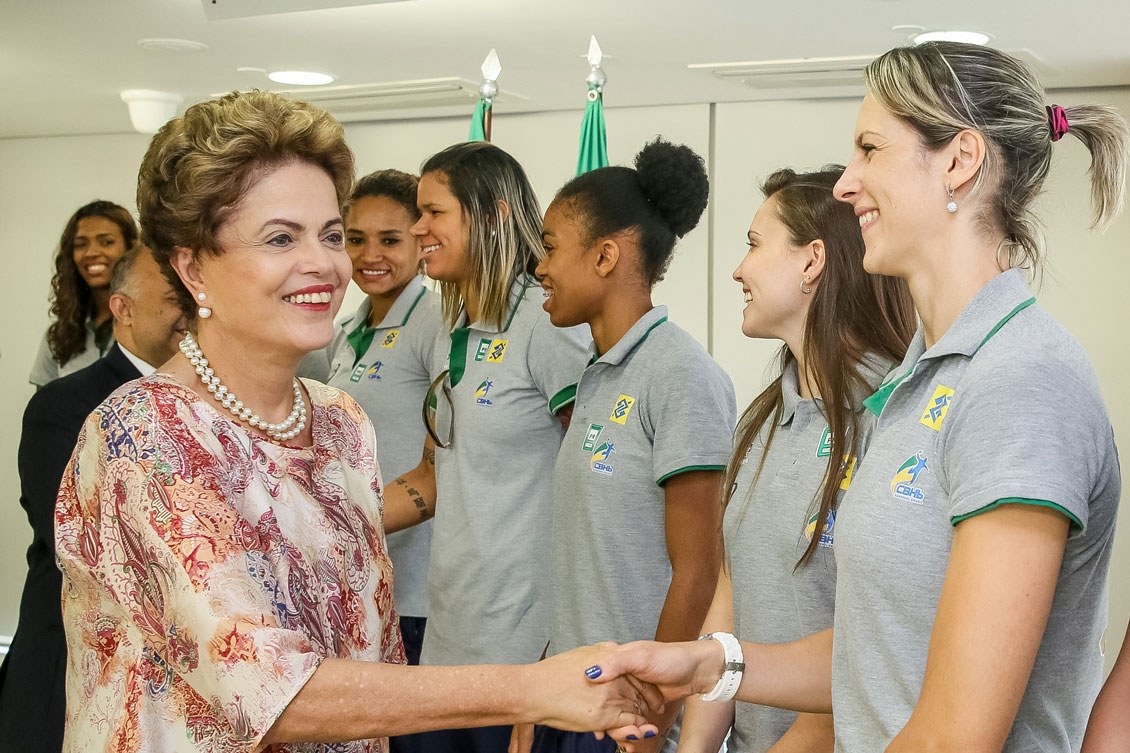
[0,0,1130,138]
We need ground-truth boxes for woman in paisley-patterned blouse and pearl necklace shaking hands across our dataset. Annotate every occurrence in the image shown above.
[57,92,655,752]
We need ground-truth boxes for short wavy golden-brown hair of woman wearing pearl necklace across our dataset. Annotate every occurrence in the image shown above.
[137,90,354,315]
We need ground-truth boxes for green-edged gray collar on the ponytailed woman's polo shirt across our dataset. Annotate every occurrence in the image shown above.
[863,269,1036,416]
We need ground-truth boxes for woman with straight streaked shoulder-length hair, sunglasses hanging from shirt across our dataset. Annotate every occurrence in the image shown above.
[390,141,591,753]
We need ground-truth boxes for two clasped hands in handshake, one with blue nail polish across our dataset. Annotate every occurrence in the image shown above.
[512,641,725,751]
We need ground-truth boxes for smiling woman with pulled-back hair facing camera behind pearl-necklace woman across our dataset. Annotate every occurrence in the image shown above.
[303,170,447,751]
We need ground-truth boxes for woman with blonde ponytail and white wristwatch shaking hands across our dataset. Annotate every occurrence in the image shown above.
[587,43,1130,753]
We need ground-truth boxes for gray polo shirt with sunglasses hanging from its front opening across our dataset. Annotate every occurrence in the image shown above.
[420,277,591,665]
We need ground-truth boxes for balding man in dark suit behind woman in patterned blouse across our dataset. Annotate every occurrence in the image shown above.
[0,245,186,753]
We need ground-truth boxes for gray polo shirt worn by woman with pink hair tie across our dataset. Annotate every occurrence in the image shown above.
[832,270,1121,753]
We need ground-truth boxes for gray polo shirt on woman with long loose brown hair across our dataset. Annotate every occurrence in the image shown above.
[723,358,890,753]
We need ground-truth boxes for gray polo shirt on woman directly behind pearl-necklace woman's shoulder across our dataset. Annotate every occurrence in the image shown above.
[321,277,446,617]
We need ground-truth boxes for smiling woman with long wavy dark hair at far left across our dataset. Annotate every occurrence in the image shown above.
[28,200,138,387]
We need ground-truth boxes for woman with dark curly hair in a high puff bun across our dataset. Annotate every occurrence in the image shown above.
[511,139,736,753]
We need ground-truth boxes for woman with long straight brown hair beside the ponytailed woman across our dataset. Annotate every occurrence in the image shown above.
[679,165,914,753]
